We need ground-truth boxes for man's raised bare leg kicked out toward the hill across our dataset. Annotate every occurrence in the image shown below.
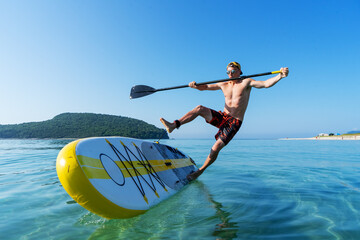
[160,105,212,133]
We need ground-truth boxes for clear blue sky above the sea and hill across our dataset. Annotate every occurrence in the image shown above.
[0,0,360,138]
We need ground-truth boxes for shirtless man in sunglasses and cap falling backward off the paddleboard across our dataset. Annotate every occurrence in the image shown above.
[160,62,289,180]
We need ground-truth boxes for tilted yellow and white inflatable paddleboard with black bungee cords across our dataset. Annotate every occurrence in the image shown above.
[56,137,197,218]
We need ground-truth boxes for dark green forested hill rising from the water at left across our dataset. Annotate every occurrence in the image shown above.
[0,113,169,139]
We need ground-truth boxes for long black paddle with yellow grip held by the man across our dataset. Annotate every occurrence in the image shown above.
[130,71,281,99]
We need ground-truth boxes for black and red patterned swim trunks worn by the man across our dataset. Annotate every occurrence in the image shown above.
[206,109,242,145]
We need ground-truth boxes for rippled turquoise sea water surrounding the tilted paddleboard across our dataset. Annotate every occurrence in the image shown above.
[0,140,360,239]
